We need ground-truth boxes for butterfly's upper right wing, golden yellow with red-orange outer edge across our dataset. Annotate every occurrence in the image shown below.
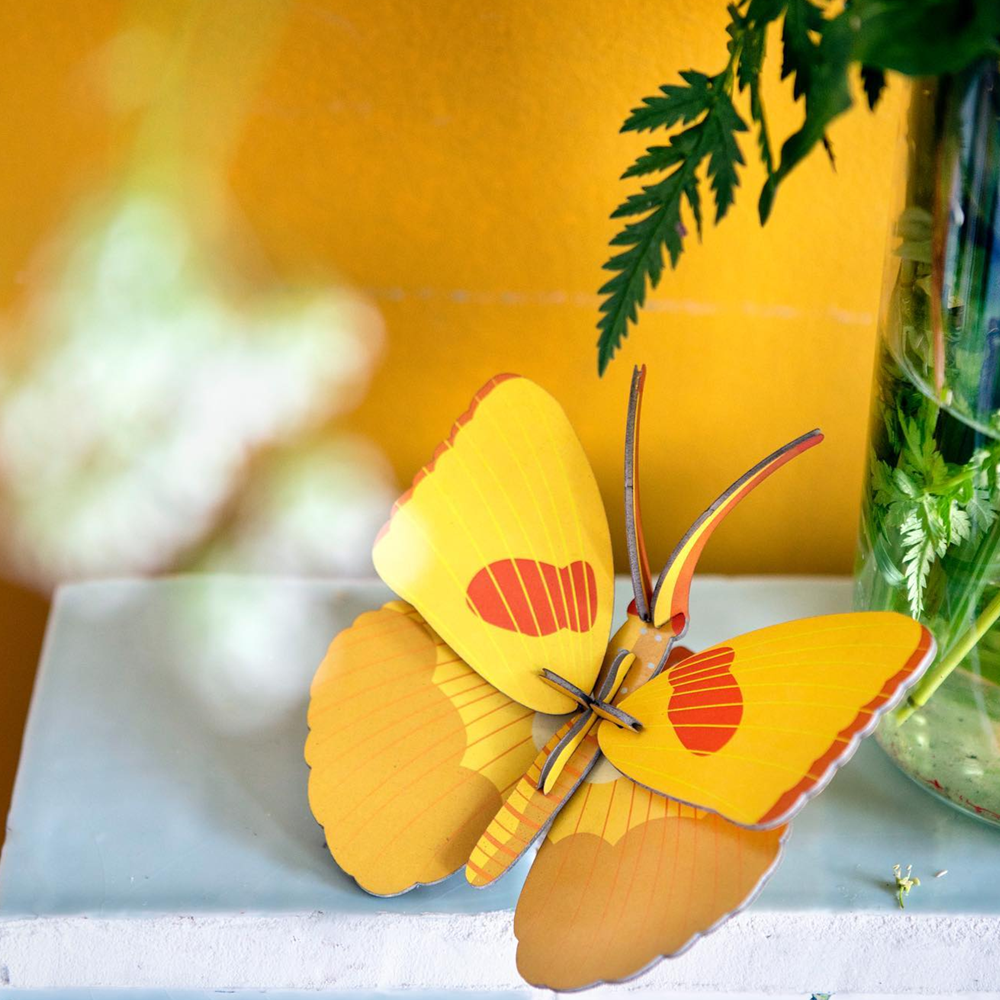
[598,612,934,828]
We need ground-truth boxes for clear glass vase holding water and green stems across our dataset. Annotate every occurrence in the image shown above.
[855,63,1000,825]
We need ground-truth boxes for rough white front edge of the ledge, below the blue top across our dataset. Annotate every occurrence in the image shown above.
[0,911,1000,996]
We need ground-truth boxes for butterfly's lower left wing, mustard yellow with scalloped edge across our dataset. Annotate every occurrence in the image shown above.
[306,601,537,895]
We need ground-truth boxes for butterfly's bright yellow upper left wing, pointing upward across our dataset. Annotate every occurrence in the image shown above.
[373,375,614,715]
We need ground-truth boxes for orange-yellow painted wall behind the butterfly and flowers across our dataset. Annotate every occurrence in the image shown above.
[0,0,898,820]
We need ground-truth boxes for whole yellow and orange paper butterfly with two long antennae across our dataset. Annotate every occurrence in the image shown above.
[306,369,934,989]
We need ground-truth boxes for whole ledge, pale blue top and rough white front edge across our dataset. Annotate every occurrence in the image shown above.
[0,577,1000,998]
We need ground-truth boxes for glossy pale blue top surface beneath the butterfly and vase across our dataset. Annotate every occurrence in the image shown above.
[0,577,1000,917]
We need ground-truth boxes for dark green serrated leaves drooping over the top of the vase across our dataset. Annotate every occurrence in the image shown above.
[598,0,1000,376]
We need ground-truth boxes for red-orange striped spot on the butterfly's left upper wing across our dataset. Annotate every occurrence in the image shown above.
[466,559,597,635]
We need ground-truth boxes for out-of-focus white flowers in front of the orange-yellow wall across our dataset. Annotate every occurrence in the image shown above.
[0,193,391,587]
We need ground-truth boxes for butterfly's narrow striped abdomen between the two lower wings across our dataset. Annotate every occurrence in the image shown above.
[465,717,598,888]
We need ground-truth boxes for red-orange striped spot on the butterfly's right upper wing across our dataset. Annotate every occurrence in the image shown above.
[667,647,743,756]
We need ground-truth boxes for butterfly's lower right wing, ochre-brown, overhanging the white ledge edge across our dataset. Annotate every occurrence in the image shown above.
[514,761,786,990]
